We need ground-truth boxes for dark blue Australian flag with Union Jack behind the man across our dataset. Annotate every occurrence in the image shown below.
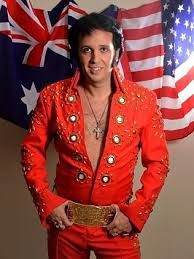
[0,0,85,128]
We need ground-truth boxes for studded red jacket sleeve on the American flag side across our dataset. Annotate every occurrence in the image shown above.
[119,93,168,232]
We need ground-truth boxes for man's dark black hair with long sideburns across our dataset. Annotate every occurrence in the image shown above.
[69,13,123,66]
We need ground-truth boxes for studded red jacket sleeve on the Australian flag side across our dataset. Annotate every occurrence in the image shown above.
[21,89,65,230]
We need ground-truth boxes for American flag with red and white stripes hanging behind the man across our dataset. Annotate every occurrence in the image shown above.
[118,0,194,140]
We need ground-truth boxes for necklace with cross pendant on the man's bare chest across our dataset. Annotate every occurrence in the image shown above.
[84,88,108,139]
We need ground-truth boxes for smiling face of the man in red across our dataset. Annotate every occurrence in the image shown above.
[78,30,115,83]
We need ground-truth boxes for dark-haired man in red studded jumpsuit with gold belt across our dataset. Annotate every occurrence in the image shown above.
[22,13,168,259]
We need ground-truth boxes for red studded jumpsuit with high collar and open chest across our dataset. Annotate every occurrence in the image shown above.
[22,69,168,259]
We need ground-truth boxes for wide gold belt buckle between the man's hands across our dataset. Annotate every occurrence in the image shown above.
[67,201,116,226]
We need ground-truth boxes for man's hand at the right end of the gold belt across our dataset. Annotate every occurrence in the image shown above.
[105,204,132,236]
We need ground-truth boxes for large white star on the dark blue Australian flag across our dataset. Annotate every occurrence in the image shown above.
[21,83,39,114]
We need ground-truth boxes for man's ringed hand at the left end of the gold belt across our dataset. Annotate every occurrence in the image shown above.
[48,201,73,230]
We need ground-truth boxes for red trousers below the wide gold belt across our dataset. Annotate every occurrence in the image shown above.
[48,224,140,259]
